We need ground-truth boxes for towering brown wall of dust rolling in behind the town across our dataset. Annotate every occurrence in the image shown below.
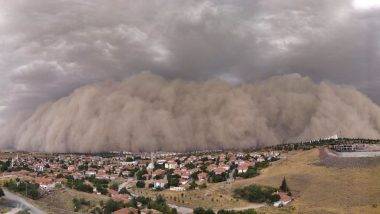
[0,72,380,152]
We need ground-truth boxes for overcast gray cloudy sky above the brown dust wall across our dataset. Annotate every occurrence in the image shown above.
[0,0,380,119]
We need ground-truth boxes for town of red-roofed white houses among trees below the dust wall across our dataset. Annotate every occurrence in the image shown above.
[1,151,280,195]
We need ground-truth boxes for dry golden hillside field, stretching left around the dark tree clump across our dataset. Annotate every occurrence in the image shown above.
[132,149,380,213]
